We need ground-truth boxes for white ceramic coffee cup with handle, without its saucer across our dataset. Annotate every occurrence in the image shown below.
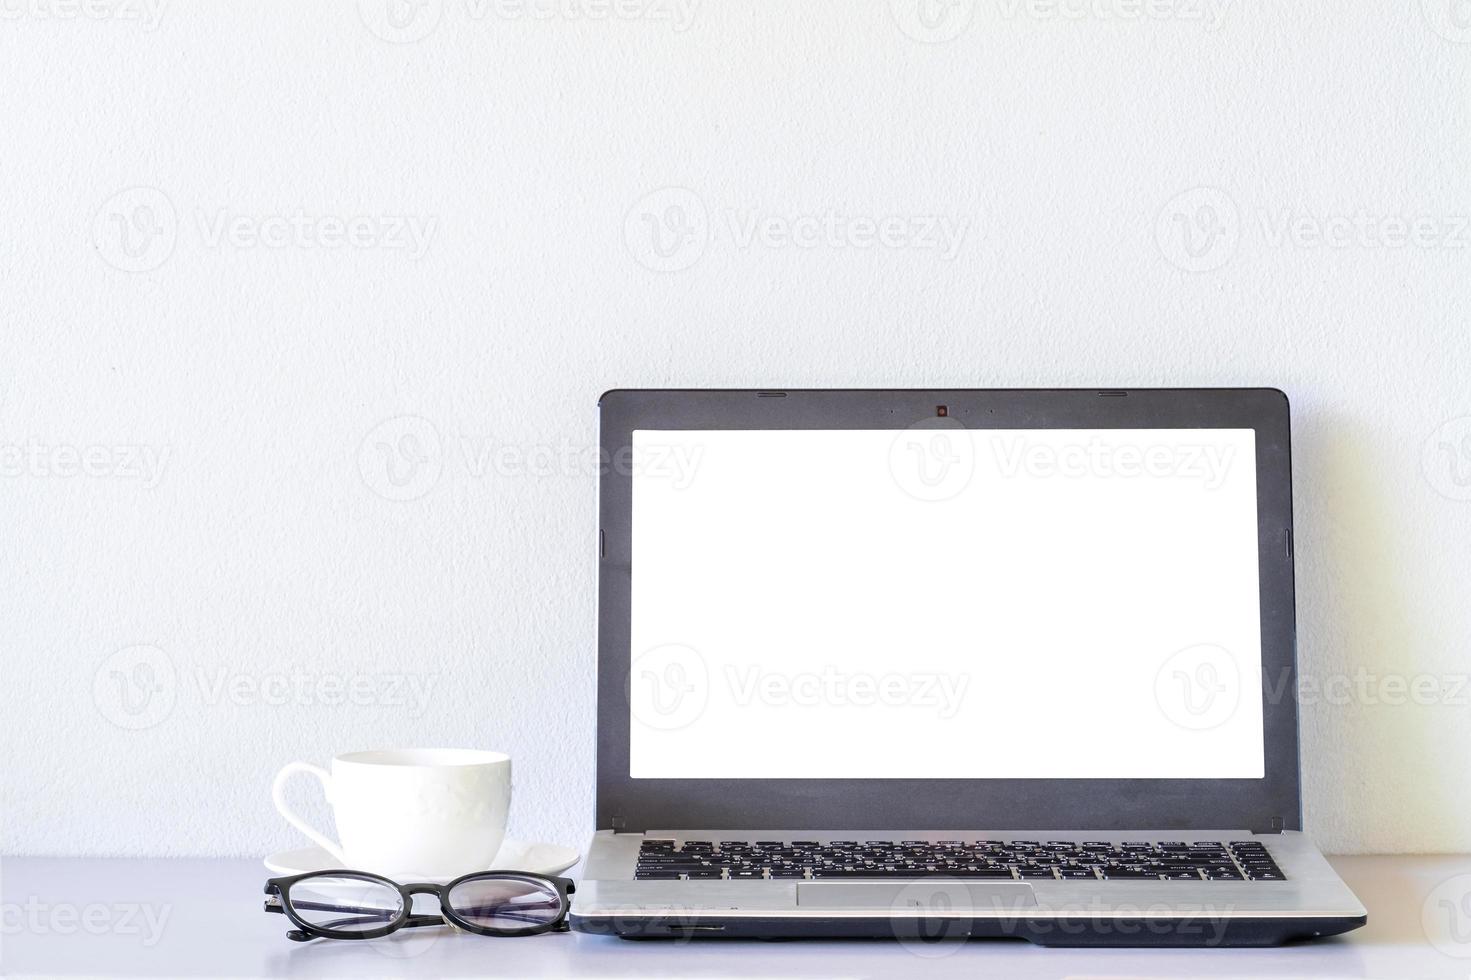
[271,749,510,880]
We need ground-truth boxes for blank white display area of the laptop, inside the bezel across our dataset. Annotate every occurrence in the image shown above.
[629,418,1264,778]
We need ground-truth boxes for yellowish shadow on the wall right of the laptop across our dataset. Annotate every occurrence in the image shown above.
[1293,415,1453,853]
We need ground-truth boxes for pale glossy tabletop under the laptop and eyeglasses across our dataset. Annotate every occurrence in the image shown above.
[0,856,1471,980]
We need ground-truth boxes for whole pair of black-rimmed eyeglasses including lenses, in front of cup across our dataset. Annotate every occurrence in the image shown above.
[265,871,575,943]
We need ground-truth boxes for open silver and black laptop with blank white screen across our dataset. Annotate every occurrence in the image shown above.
[571,388,1367,946]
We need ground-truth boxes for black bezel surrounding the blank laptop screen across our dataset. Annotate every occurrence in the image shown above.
[597,388,1302,833]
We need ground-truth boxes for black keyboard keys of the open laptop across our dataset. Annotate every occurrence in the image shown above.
[634,840,1287,881]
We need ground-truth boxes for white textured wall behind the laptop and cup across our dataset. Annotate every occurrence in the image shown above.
[0,0,1471,853]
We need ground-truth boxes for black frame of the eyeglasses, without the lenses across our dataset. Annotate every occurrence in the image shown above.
[265,868,577,942]
